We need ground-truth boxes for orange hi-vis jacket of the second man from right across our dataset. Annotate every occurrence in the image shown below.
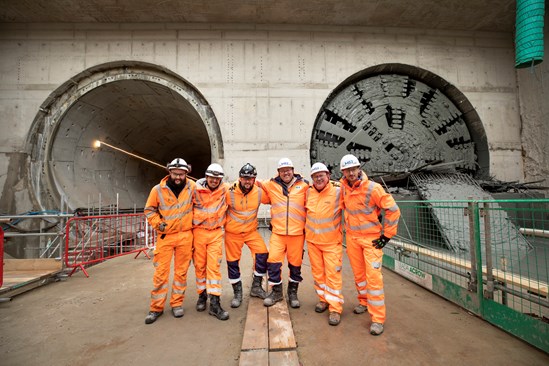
[305,182,343,244]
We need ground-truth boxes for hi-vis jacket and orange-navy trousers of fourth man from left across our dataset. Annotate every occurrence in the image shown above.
[262,174,309,285]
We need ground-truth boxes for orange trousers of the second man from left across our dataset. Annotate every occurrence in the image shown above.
[193,228,223,296]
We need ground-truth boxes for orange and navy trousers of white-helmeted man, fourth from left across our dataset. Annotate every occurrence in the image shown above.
[267,233,305,286]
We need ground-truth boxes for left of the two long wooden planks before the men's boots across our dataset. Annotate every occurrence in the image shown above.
[241,297,269,351]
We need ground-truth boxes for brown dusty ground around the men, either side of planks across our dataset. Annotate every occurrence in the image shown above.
[0,246,549,366]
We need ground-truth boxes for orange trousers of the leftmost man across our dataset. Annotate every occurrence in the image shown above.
[150,230,193,311]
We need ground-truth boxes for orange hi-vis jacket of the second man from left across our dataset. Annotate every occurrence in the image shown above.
[193,178,229,230]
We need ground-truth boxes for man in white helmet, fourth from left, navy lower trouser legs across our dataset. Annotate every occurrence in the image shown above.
[262,158,309,308]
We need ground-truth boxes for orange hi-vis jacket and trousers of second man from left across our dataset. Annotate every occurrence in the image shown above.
[193,178,229,296]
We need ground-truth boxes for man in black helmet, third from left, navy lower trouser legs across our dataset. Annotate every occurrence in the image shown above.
[225,163,269,308]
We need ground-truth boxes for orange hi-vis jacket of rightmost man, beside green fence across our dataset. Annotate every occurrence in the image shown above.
[340,172,400,238]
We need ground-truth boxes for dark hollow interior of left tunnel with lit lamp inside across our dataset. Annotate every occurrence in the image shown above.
[50,80,211,209]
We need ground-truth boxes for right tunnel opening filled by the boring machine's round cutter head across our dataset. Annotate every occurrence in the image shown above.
[310,64,489,181]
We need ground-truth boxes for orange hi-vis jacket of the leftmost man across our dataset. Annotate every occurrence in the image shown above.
[144,176,195,234]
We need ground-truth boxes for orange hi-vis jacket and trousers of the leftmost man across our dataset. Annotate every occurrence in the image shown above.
[144,176,195,312]
